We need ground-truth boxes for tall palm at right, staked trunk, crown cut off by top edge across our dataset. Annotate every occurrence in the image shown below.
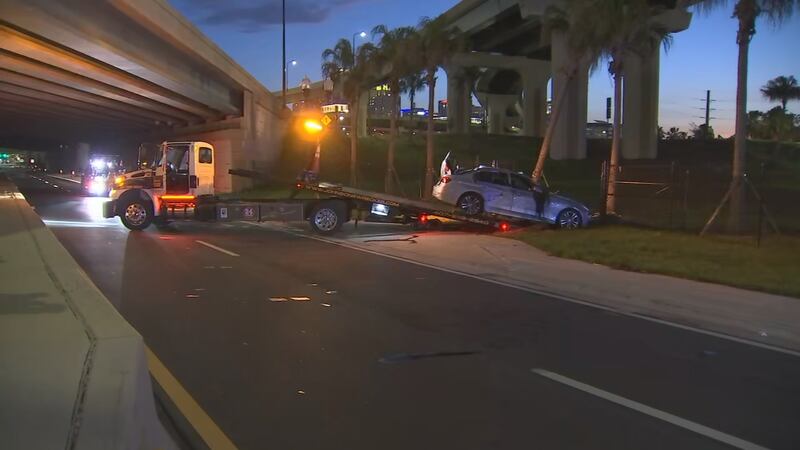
[698,0,800,232]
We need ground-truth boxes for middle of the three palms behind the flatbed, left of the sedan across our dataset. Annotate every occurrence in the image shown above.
[372,25,416,192]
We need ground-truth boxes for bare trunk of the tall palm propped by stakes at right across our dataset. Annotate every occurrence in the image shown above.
[728,16,751,233]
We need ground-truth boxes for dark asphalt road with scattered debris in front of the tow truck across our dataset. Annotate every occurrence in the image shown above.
[10,170,800,450]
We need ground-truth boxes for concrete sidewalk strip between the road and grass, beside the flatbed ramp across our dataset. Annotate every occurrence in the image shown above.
[292,224,800,352]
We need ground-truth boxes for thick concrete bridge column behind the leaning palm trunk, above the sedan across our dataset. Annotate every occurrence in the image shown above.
[550,32,589,159]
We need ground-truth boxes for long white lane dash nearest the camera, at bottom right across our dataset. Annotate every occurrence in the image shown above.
[531,369,768,450]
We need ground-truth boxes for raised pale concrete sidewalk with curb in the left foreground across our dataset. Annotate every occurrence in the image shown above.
[0,173,175,450]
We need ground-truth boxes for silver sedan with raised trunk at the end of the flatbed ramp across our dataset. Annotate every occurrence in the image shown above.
[433,166,590,229]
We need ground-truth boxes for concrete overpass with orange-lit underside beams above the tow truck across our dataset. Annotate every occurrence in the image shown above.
[0,0,285,192]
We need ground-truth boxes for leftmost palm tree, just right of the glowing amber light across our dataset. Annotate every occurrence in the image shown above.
[322,39,376,186]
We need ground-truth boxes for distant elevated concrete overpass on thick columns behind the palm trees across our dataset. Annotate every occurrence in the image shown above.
[445,0,692,159]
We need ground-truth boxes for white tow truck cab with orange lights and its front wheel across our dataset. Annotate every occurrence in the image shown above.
[103,141,215,230]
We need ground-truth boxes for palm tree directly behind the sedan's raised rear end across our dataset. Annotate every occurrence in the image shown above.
[415,16,464,198]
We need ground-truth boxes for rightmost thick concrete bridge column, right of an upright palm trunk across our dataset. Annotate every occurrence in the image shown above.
[622,49,660,159]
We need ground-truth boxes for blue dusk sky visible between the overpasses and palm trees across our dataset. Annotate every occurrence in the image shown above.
[170,0,800,136]
